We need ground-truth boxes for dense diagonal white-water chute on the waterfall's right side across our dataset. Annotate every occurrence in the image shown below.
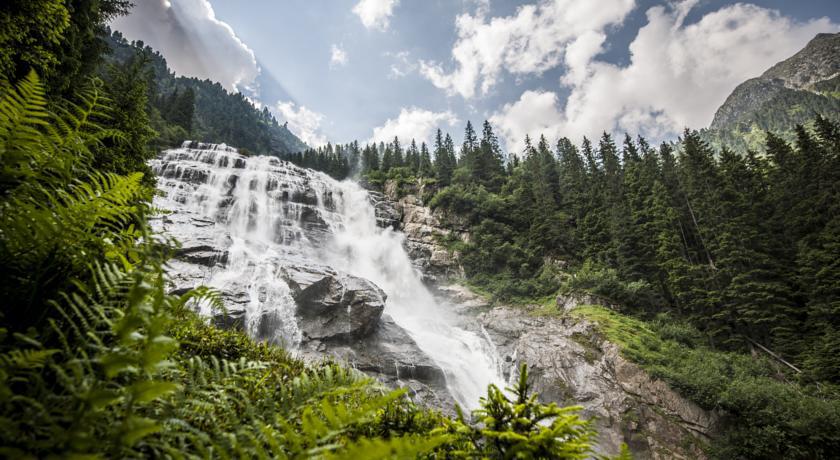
[324,181,504,408]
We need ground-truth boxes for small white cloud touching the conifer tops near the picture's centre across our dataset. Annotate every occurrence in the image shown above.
[370,107,458,144]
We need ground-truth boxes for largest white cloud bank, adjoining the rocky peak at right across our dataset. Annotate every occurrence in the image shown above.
[493,1,840,148]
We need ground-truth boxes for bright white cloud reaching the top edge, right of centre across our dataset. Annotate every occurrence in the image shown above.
[420,0,634,98]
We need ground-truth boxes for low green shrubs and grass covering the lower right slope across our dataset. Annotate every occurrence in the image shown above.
[570,306,840,459]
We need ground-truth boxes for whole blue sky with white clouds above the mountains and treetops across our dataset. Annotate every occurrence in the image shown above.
[114,0,840,151]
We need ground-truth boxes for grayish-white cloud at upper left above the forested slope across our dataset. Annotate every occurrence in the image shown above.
[111,0,260,95]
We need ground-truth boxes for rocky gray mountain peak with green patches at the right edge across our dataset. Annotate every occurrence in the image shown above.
[705,33,840,150]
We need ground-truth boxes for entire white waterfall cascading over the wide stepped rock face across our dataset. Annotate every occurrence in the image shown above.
[152,143,504,408]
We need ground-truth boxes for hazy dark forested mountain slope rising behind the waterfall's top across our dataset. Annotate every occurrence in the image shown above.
[105,31,309,155]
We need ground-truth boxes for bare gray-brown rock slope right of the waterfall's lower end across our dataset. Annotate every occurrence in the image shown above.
[439,285,718,459]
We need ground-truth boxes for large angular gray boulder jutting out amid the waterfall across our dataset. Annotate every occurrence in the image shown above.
[282,266,387,341]
